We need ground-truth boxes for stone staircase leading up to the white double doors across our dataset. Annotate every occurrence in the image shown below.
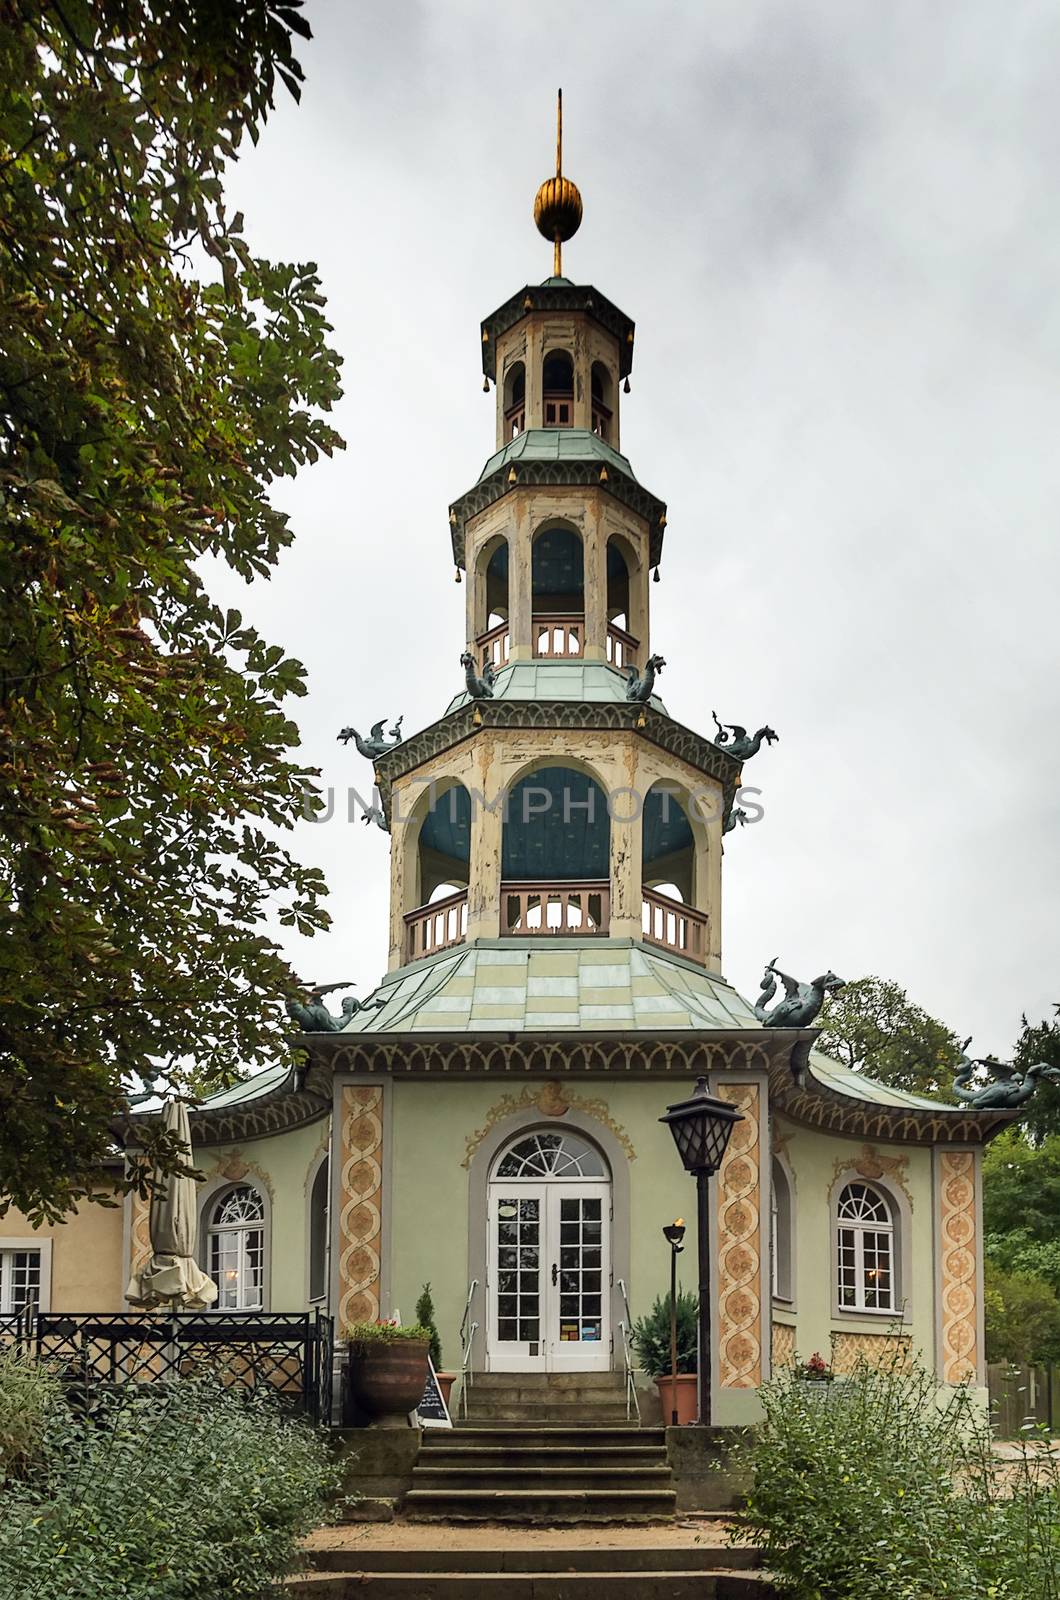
[404,1373,676,1526]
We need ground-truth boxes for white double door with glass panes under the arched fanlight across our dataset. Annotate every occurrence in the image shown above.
[487,1179,612,1373]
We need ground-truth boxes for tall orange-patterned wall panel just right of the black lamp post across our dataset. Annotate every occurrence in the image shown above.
[714,1083,762,1389]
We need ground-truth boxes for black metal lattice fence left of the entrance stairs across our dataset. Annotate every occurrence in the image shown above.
[16,1310,335,1427]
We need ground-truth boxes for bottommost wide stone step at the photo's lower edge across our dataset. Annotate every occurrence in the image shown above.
[283,1552,777,1600]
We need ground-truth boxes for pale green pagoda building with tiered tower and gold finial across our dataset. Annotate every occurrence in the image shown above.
[0,116,1015,1424]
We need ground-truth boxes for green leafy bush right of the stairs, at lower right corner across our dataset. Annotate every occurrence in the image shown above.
[743,1363,1060,1600]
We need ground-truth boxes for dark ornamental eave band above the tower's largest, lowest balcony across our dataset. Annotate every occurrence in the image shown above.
[375,699,743,826]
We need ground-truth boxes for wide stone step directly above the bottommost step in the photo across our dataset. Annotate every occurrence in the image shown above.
[302,1530,759,1573]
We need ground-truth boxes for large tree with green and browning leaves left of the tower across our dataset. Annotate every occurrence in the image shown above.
[0,0,341,1219]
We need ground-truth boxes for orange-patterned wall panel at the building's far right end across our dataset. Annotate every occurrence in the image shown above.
[938,1150,978,1384]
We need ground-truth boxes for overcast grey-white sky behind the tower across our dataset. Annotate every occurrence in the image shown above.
[215,0,1060,1053]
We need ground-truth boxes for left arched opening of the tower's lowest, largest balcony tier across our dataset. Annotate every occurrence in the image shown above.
[405,779,471,962]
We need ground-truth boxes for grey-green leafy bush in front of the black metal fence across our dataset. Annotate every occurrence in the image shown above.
[0,1379,341,1600]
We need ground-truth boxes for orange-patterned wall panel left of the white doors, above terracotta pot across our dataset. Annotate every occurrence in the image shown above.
[336,1083,383,1336]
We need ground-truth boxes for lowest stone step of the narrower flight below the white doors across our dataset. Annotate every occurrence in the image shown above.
[402,1486,677,1523]
